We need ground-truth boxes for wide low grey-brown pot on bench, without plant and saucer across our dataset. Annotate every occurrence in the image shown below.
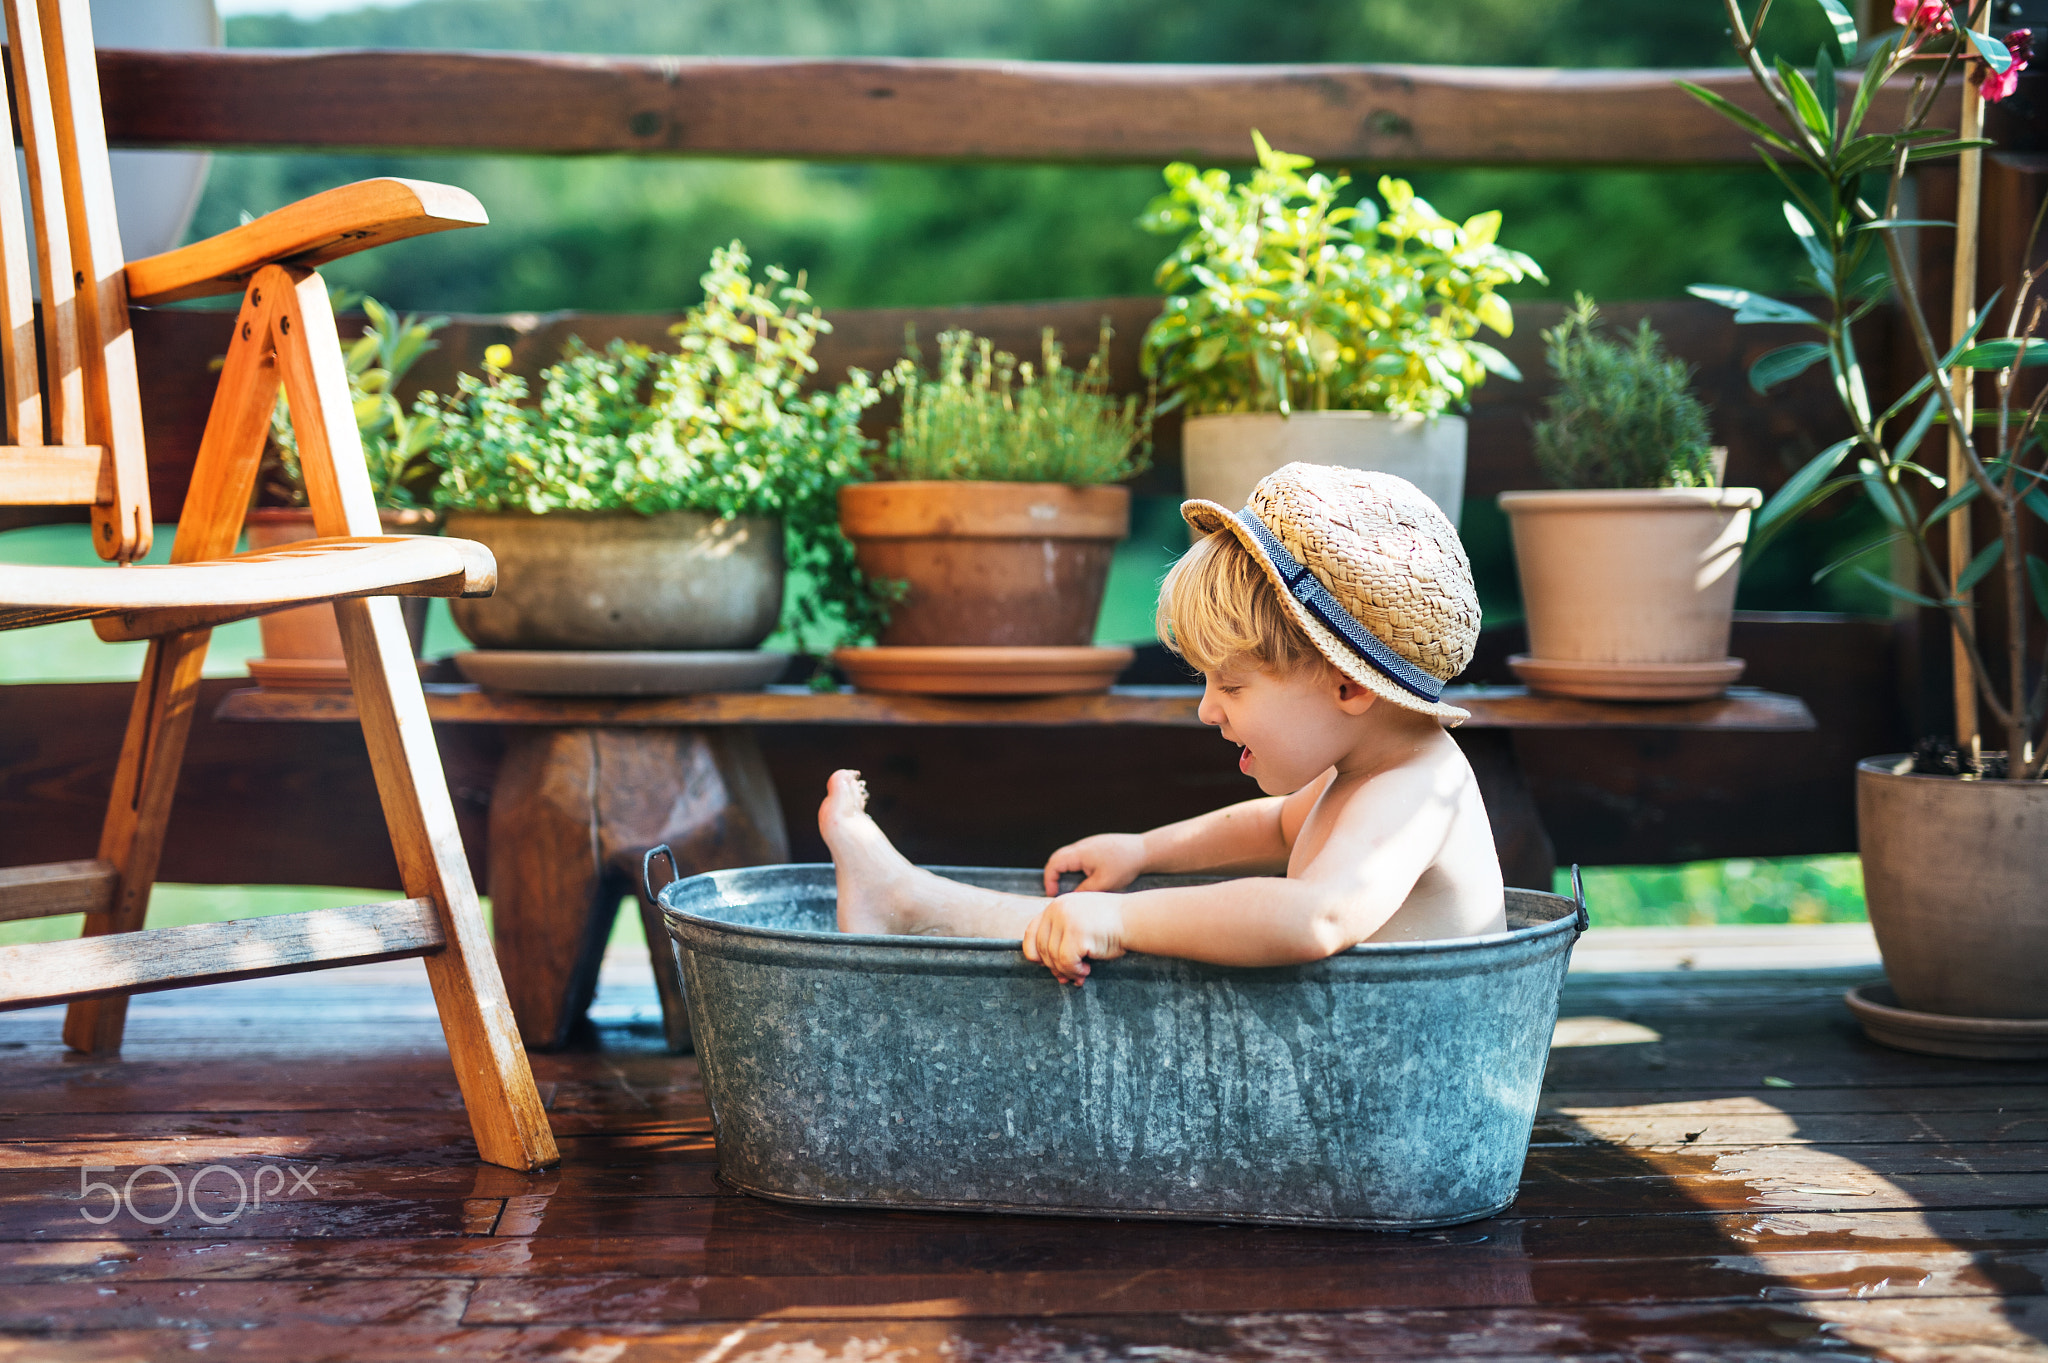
[446,512,782,651]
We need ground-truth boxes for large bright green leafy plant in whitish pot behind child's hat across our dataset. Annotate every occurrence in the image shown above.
[1143,133,1542,524]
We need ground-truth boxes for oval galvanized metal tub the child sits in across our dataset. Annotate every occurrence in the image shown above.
[649,849,1583,1230]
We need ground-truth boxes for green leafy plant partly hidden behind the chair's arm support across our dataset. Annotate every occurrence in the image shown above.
[264,299,449,512]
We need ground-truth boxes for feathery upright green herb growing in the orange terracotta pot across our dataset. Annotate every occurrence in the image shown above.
[883,323,1151,483]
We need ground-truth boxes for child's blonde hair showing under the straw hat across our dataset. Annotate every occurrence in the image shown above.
[1155,530,1329,675]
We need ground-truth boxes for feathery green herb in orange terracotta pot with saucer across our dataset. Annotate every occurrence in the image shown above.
[836,327,1149,694]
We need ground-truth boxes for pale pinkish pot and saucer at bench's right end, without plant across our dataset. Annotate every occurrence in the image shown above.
[1501,487,1763,700]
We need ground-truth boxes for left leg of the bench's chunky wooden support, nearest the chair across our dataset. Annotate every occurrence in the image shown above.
[489,729,618,1050]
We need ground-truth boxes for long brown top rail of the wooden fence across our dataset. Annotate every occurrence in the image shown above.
[88,49,1952,166]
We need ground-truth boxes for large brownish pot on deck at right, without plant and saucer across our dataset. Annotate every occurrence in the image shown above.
[1855,757,2048,1019]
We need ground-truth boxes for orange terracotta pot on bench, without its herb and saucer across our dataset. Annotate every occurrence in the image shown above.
[840,481,1130,647]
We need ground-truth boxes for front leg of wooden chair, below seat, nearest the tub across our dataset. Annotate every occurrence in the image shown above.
[334,598,561,1169]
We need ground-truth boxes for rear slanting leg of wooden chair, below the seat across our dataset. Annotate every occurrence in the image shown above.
[63,630,213,1054]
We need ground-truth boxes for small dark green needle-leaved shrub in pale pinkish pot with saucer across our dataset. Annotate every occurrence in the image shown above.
[1501,293,1763,700]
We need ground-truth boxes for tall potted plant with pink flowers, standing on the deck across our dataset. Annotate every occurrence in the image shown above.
[1692,0,2048,1043]
